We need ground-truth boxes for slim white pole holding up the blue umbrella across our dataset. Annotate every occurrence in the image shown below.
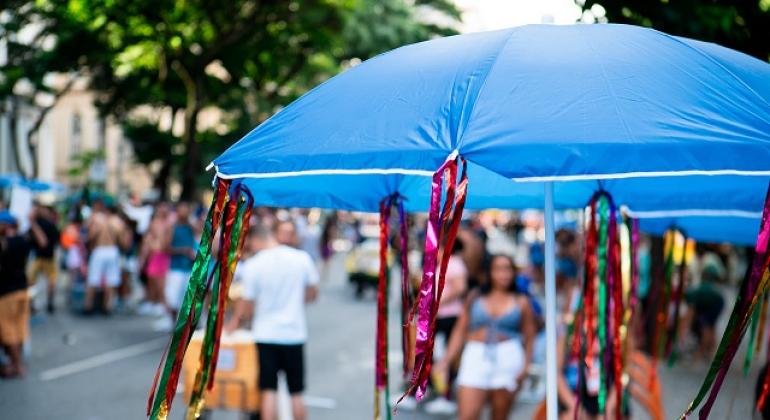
[544,182,559,420]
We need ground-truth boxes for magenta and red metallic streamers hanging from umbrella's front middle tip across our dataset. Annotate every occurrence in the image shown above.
[399,153,468,401]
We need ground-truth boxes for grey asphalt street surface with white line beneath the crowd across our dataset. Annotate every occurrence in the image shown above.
[0,254,760,420]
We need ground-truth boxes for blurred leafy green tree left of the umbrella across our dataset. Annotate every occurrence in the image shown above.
[0,0,459,198]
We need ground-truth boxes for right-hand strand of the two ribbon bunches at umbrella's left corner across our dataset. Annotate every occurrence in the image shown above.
[187,183,253,420]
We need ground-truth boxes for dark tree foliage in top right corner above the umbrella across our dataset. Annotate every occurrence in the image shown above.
[575,0,770,61]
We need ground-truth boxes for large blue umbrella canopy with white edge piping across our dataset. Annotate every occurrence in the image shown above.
[214,25,770,211]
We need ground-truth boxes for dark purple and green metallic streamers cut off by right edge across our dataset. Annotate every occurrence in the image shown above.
[682,182,770,419]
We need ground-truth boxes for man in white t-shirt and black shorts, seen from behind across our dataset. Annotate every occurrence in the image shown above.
[227,221,318,420]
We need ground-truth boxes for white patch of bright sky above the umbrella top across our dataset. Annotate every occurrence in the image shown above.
[455,0,581,33]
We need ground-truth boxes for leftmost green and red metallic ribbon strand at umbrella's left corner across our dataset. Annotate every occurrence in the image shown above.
[147,179,230,420]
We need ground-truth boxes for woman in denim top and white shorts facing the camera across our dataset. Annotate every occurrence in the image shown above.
[436,255,536,420]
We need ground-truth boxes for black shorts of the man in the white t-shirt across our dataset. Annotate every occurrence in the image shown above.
[257,343,305,394]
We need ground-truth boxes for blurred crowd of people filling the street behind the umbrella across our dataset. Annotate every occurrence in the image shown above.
[0,199,740,419]
